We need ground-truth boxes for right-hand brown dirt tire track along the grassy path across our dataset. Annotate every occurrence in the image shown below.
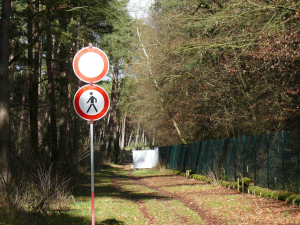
[128,171,227,225]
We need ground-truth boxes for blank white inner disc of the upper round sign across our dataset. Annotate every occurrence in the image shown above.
[78,52,104,78]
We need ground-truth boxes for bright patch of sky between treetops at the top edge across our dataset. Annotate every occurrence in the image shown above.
[128,0,154,18]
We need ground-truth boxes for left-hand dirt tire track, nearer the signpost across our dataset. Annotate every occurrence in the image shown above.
[111,173,157,225]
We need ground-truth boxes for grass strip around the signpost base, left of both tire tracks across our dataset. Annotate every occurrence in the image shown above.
[50,167,146,224]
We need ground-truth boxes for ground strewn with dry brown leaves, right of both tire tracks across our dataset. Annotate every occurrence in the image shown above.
[136,176,300,224]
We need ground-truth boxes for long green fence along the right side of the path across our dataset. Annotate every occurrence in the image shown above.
[159,130,300,193]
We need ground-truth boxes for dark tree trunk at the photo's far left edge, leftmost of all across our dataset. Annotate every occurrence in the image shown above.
[0,0,11,170]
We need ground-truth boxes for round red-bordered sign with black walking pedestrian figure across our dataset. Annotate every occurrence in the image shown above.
[73,85,110,120]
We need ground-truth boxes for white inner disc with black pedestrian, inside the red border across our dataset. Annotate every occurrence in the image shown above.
[79,90,104,116]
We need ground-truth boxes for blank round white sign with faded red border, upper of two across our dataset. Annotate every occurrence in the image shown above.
[73,45,109,83]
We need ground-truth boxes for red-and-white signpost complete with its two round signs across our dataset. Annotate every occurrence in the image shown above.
[73,43,110,225]
